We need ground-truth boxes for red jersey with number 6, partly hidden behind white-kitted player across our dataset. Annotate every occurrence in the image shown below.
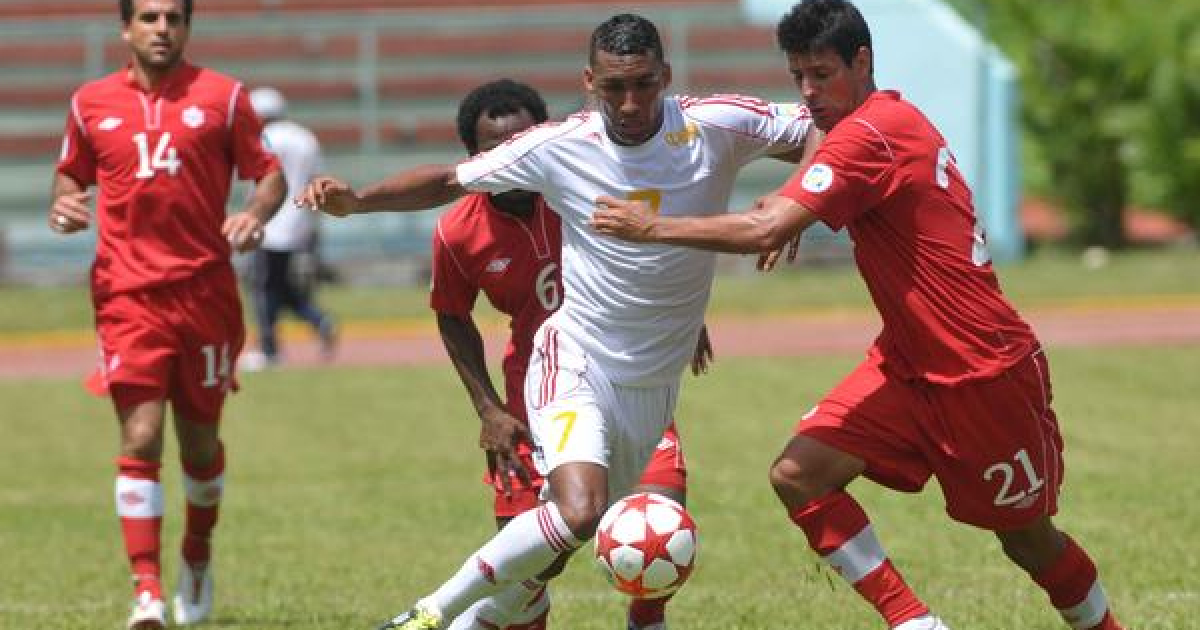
[430,193,563,403]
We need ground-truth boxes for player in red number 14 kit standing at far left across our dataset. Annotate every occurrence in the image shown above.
[48,0,286,628]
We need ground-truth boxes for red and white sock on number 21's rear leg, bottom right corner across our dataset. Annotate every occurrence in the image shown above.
[1033,534,1122,630]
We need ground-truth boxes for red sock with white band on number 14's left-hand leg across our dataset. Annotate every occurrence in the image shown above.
[115,457,162,598]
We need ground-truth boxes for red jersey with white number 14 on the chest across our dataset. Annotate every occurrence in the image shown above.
[58,62,278,296]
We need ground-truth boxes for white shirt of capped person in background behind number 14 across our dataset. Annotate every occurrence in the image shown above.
[262,120,320,252]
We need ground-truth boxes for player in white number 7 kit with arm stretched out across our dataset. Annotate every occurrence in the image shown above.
[298,14,818,630]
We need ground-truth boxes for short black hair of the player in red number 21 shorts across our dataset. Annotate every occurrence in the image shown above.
[775,0,874,65]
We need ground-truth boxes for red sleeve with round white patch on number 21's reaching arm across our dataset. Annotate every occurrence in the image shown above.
[779,119,896,230]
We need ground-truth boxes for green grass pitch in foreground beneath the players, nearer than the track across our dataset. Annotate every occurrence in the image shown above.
[0,347,1200,630]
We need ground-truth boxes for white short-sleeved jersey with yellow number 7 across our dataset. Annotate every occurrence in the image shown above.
[457,96,811,386]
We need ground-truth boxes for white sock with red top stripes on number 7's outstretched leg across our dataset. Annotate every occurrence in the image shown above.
[422,503,582,620]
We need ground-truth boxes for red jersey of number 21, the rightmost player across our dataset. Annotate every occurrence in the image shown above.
[780,91,1037,384]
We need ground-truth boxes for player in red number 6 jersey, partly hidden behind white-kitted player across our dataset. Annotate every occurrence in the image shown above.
[430,79,696,630]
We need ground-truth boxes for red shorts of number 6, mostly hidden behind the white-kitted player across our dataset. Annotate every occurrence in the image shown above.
[484,415,688,518]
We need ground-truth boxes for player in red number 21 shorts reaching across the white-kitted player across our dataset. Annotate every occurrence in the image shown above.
[593,0,1120,630]
